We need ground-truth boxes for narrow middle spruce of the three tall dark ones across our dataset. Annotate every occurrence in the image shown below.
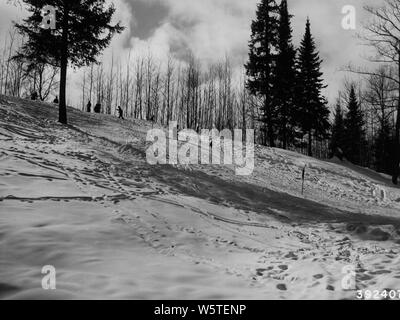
[274,0,296,149]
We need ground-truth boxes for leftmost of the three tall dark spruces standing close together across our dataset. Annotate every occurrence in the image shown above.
[245,0,279,147]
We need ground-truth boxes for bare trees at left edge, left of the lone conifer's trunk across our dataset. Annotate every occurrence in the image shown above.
[0,28,59,101]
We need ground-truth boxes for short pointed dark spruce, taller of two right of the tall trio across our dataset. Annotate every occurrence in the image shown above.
[344,86,365,165]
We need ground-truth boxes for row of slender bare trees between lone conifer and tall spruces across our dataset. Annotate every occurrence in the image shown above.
[81,54,253,130]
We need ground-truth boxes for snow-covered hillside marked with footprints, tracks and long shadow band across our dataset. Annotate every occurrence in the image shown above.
[0,96,400,299]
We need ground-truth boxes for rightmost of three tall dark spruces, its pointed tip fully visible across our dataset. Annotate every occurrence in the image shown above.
[296,19,330,156]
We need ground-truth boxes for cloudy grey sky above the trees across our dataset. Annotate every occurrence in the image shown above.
[0,0,382,103]
